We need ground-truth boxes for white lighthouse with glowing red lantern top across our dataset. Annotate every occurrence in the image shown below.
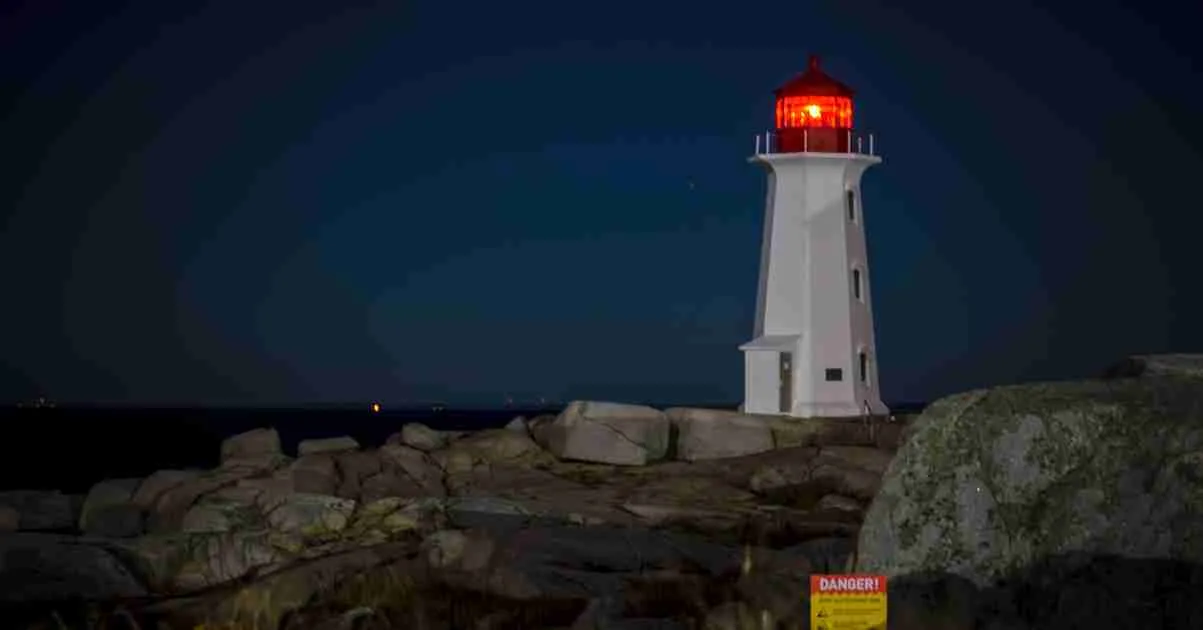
[740,57,887,417]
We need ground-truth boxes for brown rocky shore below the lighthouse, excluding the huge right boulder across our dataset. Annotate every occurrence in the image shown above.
[0,402,902,628]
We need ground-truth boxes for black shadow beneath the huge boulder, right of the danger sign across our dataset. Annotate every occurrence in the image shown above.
[889,553,1203,630]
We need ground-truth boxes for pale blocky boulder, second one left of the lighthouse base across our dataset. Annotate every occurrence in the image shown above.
[535,400,670,466]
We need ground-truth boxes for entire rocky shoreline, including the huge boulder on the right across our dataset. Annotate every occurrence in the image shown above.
[0,356,1203,630]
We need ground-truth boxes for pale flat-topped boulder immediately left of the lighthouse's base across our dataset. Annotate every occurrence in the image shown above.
[665,408,772,462]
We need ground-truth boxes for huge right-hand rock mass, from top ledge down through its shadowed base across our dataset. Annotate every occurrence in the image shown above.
[857,365,1203,629]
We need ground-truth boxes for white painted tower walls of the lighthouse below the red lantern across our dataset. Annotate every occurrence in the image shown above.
[740,153,887,417]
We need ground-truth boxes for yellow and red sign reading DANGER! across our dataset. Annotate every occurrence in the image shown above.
[811,575,887,630]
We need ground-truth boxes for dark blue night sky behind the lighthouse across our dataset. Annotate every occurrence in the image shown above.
[0,0,1203,404]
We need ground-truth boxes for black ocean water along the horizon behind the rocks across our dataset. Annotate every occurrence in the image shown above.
[0,403,921,493]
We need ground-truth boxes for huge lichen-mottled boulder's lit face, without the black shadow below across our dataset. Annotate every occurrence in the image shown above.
[859,379,1203,586]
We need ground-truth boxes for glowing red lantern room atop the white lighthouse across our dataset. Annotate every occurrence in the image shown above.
[775,55,853,153]
